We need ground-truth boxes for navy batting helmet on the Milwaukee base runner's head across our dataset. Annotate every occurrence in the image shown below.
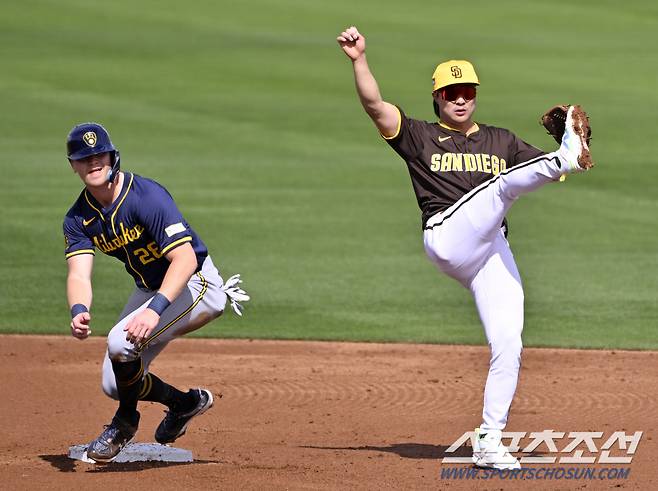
[66,123,121,182]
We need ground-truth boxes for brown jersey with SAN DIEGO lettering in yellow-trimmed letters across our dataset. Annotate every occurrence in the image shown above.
[384,108,546,226]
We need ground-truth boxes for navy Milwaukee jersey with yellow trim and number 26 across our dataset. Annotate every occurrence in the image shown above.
[64,172,208,290]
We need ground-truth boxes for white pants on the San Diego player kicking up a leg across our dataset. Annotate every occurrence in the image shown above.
[424,152,566,430]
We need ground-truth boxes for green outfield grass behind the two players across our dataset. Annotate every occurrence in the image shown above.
[0,0,658,349]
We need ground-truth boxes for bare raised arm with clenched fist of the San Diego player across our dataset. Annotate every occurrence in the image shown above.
[336,26,400,137]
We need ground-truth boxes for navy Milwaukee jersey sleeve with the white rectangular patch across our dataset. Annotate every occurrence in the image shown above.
[140,181,192,255]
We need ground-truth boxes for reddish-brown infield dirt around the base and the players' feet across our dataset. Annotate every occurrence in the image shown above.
[0,336,658,490]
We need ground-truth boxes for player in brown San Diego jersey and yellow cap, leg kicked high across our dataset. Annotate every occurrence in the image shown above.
[337,26,593,469]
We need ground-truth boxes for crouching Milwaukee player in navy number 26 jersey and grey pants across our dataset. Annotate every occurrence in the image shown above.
[64,123,249,462]
